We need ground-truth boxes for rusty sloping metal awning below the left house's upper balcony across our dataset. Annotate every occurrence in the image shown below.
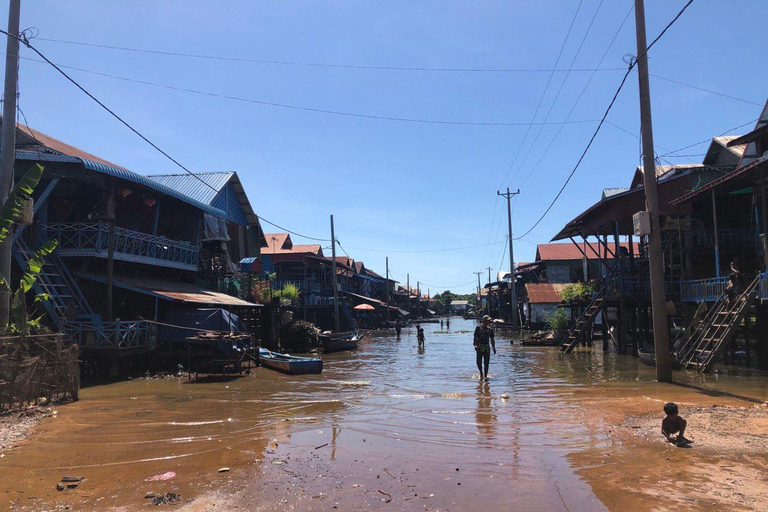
[75,272,262,308]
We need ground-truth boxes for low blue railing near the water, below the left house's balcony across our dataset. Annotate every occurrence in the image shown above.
[62,320,156,350]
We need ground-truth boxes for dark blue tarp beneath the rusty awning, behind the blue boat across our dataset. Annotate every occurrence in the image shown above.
[157,308,248,354]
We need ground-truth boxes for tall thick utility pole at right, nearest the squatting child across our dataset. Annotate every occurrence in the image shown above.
[635,0,672,382]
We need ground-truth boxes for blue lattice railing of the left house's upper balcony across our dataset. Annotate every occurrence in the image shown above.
[41,222,200,270]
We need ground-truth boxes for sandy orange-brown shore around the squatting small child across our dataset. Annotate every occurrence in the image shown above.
[570,385,768,511]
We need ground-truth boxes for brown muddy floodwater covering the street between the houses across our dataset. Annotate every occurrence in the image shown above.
[0,319,768,511]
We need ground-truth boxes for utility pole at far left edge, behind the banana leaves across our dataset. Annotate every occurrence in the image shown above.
[0,0,21,326]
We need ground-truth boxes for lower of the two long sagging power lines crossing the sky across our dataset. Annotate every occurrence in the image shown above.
[13,53,597,126]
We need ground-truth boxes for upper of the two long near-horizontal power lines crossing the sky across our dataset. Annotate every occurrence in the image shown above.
[36,37,623,73]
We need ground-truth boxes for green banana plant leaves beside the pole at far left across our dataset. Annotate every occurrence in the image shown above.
[0,164,57,332]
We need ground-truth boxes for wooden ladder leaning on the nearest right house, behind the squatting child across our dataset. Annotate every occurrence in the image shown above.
[676,276,759,373]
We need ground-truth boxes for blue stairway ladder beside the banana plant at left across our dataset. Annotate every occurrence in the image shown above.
[13,237,94,329]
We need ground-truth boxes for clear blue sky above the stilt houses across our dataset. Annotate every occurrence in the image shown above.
[3,0,768,293]
